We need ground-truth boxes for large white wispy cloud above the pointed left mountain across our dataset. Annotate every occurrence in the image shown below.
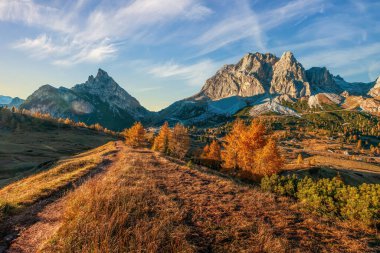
[0,0,212,66]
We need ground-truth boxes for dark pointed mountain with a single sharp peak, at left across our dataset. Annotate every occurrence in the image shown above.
[20,69,152,130]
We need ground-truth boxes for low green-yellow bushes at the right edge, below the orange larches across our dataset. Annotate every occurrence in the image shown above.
[261,175,380,225]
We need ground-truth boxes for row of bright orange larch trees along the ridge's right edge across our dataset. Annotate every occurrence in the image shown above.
[122,119,284,181]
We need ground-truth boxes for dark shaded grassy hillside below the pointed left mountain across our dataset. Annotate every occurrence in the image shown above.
[0,109,114,187]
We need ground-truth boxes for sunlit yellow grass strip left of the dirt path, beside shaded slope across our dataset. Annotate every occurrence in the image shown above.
[0,142,116,221]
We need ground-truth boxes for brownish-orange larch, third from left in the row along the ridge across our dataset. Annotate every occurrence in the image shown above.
[169,123,190,159]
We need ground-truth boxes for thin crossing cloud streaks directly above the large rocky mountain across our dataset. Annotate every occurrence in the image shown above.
[193,0,324,56]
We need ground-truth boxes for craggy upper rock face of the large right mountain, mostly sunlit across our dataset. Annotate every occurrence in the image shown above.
[191,52,343,100]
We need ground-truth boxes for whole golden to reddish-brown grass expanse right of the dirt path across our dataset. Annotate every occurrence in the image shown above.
[36,149,375,253]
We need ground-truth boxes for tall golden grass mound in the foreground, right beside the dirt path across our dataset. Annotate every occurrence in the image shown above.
[41,152,195,252]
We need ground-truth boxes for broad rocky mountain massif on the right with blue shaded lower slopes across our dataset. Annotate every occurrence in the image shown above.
[156,52,380,124]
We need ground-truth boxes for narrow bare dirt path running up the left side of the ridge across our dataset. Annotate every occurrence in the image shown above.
[0,142,123,253]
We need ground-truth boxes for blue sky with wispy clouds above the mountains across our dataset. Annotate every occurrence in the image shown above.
[0,0,380,111]
